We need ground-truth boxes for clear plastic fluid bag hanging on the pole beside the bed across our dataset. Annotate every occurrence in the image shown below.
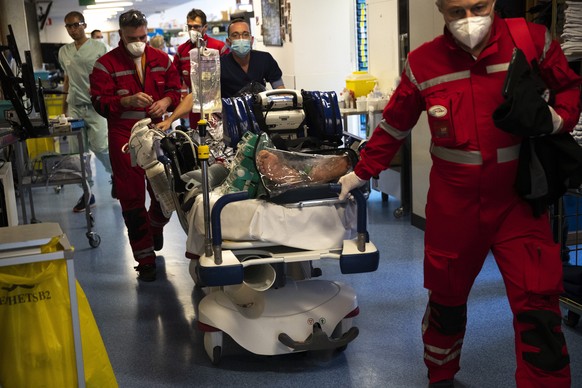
[190,48,222,113]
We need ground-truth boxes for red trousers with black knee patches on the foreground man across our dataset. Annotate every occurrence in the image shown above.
[422,160,570,388]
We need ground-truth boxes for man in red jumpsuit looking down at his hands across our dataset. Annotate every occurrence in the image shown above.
[90,10,180,281]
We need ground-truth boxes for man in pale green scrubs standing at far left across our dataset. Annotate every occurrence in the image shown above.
[58,11,111,213]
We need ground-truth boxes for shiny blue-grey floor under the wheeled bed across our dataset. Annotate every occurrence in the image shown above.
[16,159,582,388]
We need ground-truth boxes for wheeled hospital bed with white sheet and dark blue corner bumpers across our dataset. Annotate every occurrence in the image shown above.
[128,88,379,364]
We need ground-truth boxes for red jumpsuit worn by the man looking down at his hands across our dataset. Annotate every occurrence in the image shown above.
[90,42,180,265]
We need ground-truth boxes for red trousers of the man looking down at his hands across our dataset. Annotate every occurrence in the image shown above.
[109,131,169,264]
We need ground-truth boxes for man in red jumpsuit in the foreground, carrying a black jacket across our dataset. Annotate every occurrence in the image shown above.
[340,0,581,388]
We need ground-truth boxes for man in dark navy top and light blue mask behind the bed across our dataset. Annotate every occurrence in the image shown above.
[220,19,285,98]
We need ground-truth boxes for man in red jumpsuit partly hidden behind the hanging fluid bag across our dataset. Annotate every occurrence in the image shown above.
[174,8,228,128]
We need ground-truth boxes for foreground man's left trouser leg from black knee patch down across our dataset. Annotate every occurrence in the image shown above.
[422,301,467,382]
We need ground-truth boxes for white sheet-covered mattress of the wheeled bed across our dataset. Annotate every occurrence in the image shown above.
[186,192,357,255]
